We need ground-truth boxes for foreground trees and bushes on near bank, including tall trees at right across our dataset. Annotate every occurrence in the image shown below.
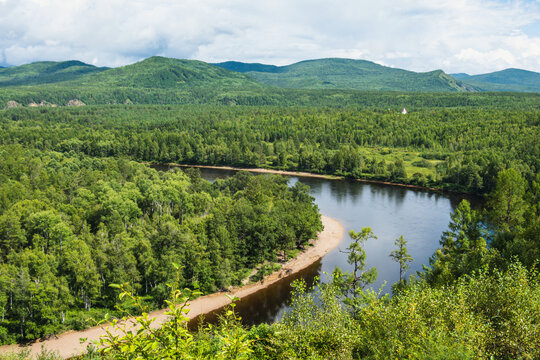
[3,165,540,360]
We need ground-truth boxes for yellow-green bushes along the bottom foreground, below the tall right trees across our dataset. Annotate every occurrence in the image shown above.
[2,263,540,360]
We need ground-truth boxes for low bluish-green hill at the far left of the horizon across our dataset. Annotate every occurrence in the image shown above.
[0,60,108,87]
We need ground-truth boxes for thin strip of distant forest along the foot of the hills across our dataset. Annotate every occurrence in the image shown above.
[0,84,540,111]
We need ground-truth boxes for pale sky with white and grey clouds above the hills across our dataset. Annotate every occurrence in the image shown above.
[0,0,540,74]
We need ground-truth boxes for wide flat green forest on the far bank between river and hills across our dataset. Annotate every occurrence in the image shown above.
[0,106,540,193]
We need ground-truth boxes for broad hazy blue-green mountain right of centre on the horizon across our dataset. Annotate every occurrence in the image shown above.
[215,58,475,92]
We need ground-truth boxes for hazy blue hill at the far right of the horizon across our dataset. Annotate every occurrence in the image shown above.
[452,69,540,92]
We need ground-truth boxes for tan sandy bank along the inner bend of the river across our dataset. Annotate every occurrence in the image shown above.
[0,215,344,359]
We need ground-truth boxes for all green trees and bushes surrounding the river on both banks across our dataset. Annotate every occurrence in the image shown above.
[0,90,540,359]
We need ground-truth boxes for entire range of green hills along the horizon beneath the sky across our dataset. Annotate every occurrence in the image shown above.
[0,56,540,92]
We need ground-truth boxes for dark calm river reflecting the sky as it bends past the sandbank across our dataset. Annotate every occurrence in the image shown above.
[158,169,481,325]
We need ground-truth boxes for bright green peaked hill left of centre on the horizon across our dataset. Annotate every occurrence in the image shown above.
[72,56,261,89]
